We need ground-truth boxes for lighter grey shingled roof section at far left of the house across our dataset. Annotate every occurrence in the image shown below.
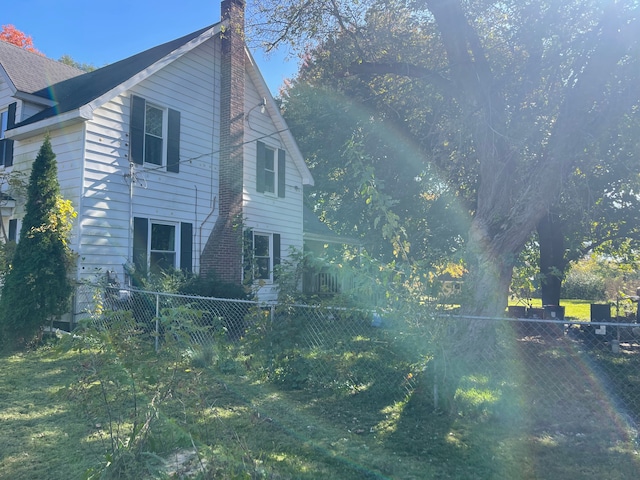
[0,41,84,93]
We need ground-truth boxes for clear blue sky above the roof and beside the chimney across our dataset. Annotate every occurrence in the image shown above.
[0,0,297,95]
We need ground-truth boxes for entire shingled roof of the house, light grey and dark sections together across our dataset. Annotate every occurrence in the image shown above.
[0,26,212,128]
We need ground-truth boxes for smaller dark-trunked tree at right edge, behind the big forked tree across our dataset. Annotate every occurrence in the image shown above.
[537,107,640,305]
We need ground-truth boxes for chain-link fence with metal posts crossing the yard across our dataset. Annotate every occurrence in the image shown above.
[74,285,640,428]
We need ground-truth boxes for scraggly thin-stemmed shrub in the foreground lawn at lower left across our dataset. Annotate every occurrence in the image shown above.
[61,311,195,479]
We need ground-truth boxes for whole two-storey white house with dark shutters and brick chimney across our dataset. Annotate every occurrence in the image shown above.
[0,0,313,300]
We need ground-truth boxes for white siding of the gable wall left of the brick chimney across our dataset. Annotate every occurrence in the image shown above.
[81,40,219,281]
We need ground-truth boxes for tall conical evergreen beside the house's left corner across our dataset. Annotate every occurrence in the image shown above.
[0,137,75,343]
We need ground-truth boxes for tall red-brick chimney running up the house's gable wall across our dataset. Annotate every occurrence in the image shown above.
[200,0,245,285]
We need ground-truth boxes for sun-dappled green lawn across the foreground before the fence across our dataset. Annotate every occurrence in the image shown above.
[0,322,640,480]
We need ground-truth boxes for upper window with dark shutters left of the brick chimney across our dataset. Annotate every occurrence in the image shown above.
[131,95,180,173]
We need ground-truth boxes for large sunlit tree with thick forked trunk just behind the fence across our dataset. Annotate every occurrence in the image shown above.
[251,0,640,322]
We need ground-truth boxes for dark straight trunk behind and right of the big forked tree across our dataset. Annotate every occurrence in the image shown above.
[537,212,566,305]
